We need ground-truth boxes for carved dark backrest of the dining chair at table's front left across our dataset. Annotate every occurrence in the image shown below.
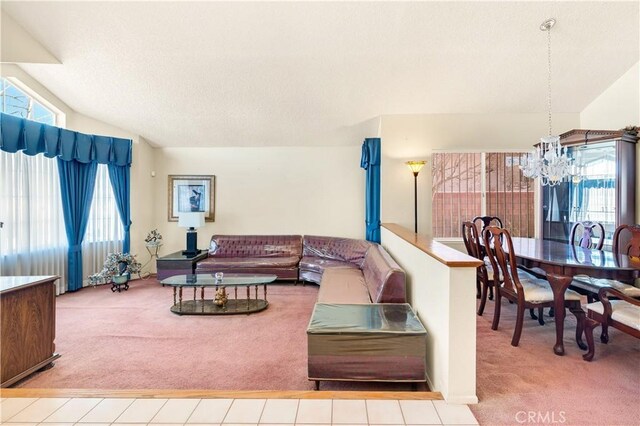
[482,226,524,300]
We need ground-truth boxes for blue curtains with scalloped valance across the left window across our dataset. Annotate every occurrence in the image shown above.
[0,113,132,291]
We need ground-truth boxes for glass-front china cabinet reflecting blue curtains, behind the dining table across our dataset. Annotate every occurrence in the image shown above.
[540,130,638,248]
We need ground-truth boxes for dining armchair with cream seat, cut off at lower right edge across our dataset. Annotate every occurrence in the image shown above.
[582,287,640,361]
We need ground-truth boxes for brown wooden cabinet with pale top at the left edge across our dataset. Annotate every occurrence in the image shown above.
[0,276,60,387]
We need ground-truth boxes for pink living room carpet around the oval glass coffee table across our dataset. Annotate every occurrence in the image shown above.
[17,279,420,390]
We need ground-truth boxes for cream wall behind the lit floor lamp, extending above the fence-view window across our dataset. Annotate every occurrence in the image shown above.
[381,114,580,235]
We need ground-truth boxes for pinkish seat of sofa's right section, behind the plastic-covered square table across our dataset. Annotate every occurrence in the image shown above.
[318,268,371,303]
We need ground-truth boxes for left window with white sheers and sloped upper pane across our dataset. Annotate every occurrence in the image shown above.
[0,78,124,293]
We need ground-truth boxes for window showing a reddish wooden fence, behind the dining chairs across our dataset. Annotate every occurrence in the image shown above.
[431,152,534,238]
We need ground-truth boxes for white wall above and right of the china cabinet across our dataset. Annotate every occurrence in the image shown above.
[580,62,640,223]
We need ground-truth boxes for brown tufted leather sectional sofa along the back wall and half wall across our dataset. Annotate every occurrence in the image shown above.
[196,235,406,303]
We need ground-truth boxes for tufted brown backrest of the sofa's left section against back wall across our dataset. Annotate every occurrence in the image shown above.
[209,235,302,262]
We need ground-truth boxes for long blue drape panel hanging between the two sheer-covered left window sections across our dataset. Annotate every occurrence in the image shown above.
[58,158,98,291]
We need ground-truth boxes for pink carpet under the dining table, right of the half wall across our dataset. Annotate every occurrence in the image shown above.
[470,301,640,426]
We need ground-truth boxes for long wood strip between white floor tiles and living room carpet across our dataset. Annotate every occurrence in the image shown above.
[0,388,443,400]
